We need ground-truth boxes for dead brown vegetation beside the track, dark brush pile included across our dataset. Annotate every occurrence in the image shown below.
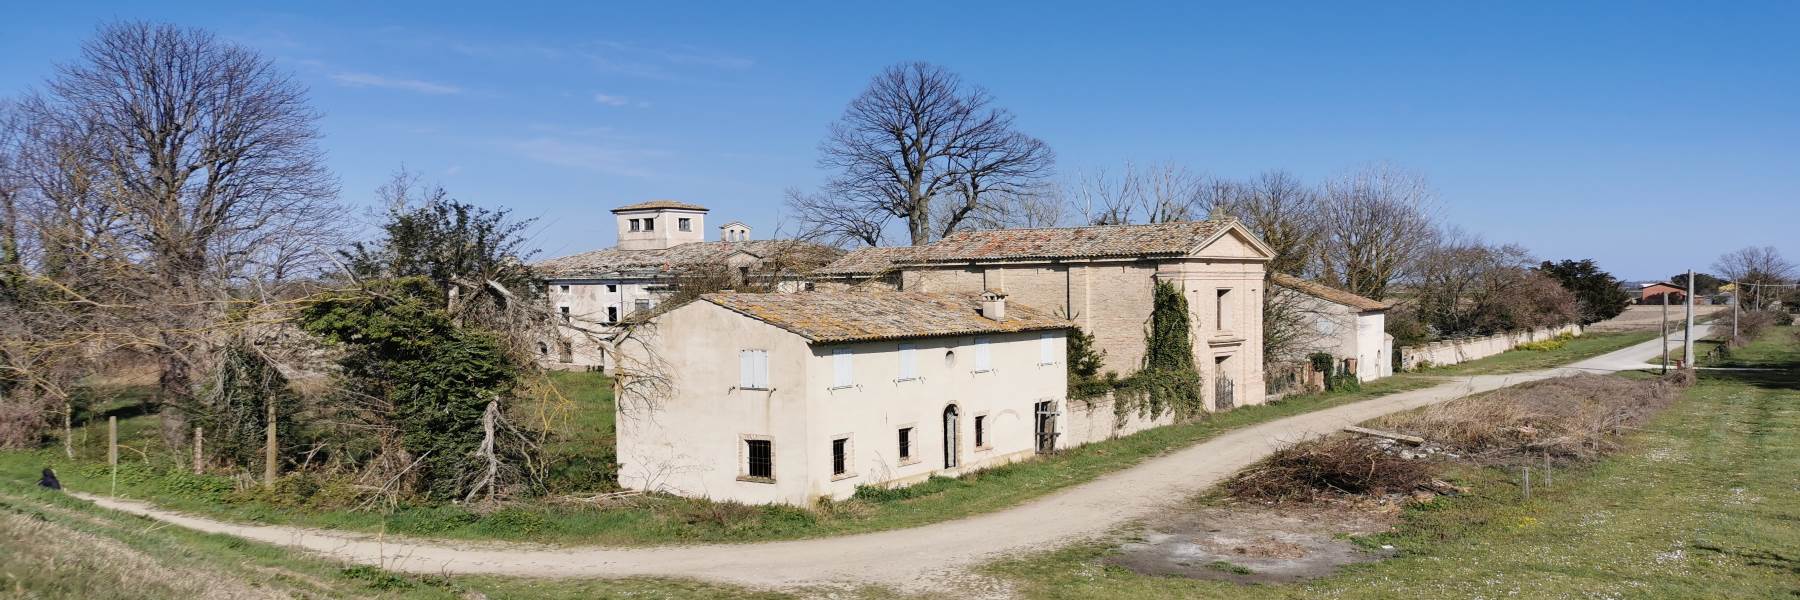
[1224,371,1694,503]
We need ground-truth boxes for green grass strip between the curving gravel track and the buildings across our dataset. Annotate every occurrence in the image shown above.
[0,333,1640,546]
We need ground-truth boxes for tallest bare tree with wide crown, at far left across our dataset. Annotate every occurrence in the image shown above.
[32,22,337,436]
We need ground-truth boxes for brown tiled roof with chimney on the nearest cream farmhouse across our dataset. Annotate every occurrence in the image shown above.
[700,292,1075,342]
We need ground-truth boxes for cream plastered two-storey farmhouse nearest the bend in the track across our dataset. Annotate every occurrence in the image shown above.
[616,290,1073,506]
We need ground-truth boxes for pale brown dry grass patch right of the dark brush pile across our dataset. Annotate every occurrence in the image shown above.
[1373,371,1692,463]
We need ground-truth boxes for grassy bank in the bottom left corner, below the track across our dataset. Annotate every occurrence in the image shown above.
[0,481,787,600]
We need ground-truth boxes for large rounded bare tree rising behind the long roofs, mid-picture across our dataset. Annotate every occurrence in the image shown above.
[790,63,1055,245]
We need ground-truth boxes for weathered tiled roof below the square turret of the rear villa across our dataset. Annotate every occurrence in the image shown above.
[533,240,842,279]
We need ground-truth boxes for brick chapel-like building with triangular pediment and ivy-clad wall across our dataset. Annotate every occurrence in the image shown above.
[817,220,1273,409]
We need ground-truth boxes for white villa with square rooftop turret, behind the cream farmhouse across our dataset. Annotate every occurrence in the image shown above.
[535,200,842,369]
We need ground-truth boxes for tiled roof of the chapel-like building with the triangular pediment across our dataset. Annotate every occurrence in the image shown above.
[913,220,1233,263]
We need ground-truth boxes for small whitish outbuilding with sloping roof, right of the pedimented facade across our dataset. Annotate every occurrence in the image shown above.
[1269,274,1393,382]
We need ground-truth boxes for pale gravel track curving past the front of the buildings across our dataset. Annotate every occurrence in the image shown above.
[81,326,1705,591]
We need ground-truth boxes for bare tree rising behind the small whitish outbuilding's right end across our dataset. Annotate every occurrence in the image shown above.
[1319,166,1436,299]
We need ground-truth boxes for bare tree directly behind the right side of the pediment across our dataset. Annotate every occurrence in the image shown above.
[1206,171,1323,277]
